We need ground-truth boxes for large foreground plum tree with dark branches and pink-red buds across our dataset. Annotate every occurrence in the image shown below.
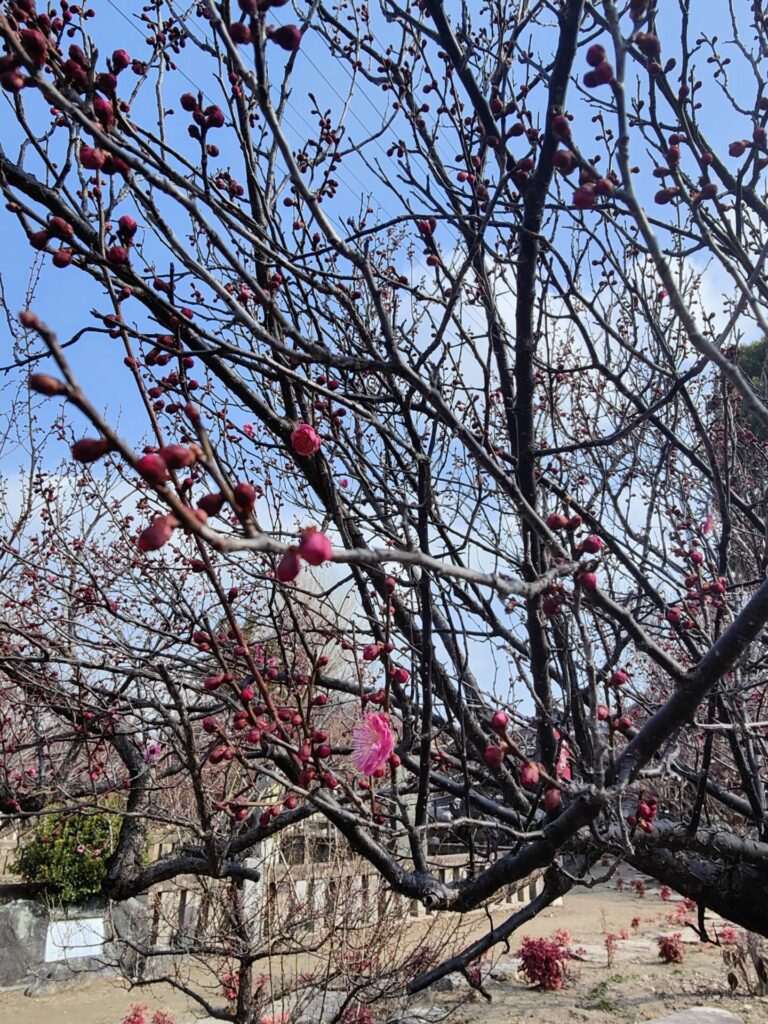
[0,0,768,989]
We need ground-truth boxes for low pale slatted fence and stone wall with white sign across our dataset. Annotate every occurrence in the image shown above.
[0,823,562,990]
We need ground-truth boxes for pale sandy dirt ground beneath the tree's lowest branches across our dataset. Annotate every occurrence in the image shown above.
[0,889,768,1024]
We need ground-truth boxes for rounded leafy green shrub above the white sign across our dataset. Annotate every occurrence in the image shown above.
[13,811,117,903]
